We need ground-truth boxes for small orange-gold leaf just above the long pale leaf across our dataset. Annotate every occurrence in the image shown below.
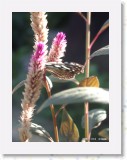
[79,76,99,87]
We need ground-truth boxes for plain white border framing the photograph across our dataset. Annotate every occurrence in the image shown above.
[0,0,121,154]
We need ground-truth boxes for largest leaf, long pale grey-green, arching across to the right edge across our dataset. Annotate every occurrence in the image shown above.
[37,87,109,113]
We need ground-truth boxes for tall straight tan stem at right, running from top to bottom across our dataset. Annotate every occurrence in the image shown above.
[84,12,91,142]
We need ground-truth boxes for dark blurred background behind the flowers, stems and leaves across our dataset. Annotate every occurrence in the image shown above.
[12,12,109,141]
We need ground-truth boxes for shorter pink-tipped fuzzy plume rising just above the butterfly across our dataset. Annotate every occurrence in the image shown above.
[47,32,67,62]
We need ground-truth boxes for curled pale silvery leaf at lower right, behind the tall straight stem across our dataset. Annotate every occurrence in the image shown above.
[81,109,107,131]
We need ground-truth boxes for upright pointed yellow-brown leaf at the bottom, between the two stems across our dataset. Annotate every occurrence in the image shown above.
[60,109,79,142]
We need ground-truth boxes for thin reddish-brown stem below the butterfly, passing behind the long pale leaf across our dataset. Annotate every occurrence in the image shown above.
[45,77,59,142]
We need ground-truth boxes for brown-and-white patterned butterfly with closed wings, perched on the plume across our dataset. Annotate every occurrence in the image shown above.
[46,62,84,80]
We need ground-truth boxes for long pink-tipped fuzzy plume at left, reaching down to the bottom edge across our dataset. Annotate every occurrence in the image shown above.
[19,42,45,142]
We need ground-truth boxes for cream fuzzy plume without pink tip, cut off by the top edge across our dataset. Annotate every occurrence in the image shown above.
[30,12,49,49]
